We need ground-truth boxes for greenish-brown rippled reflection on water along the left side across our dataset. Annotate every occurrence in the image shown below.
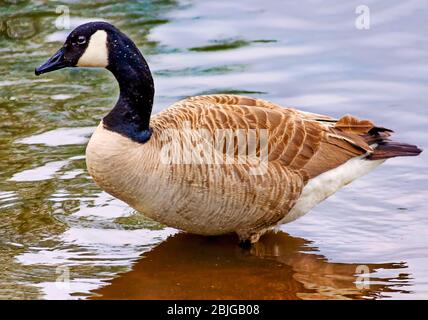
[0,1,176,299]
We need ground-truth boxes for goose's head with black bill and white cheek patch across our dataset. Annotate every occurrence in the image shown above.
[35,22,130,75]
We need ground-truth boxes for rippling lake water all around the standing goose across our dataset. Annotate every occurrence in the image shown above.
[0,0,428,299]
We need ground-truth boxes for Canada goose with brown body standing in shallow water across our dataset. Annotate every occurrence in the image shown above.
[35,22,421,244]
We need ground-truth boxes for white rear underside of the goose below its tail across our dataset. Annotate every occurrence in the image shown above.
[279,157,385,224]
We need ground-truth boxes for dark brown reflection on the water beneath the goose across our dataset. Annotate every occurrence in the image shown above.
[94,232,409,299]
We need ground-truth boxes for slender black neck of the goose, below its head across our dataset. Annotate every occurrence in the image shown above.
[103,34,154,143]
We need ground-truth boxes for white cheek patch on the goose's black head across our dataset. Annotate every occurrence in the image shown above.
[77,30,108,68]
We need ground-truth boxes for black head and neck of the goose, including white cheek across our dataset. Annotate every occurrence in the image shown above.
[35,22,154,142]
